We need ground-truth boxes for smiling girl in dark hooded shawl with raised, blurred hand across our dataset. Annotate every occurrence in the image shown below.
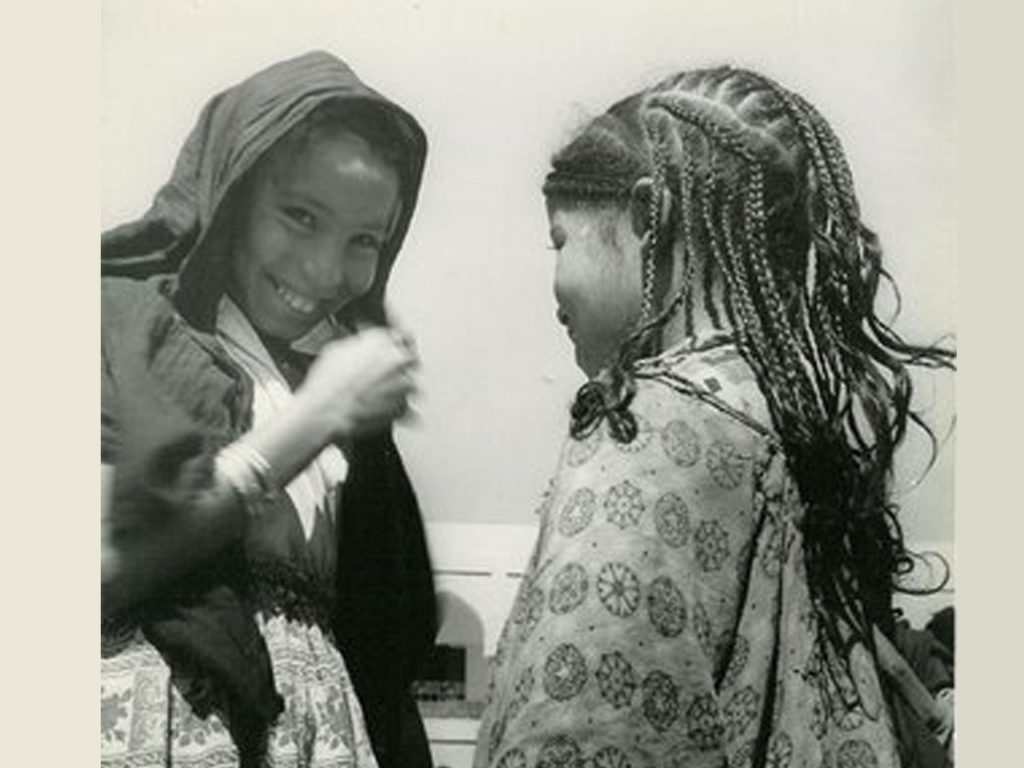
[101,53,436,768]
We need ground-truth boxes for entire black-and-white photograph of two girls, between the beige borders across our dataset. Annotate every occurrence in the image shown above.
[96,0,958,768]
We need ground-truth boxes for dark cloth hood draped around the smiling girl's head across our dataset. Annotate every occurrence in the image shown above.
[101,51,427,330]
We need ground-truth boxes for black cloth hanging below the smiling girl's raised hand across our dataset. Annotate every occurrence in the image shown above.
[335,434,437,768]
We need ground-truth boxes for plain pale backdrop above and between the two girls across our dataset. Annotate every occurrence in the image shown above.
[101,0,955,540]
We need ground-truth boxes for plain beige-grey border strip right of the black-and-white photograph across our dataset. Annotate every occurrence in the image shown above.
[955,0,1011,766]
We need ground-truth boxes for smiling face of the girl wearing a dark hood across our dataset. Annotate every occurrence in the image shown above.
[227,130,400,341]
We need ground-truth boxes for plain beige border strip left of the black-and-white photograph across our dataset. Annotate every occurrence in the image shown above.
[8,2,99,766]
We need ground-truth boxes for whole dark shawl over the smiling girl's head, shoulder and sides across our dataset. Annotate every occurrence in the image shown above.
[101,52,436,767]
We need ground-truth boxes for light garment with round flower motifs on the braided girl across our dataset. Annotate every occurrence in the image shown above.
[475,340,898,768]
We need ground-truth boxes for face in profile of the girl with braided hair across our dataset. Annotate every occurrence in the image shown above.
[548,199,642,378]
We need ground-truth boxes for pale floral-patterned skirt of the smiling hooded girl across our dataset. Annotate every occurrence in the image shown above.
[100,615,377,768]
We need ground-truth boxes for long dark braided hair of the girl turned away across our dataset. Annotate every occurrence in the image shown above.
[544,67,954,695]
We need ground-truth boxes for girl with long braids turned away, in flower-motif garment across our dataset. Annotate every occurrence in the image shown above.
[476,67,953,768]
